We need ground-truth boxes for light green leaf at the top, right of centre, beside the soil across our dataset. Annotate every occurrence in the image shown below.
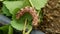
[29,0,48,10]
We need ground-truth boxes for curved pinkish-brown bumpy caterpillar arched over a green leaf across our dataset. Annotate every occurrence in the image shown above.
[16,6,39,26]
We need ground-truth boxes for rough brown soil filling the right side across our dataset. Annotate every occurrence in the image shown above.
[40,0,60,34]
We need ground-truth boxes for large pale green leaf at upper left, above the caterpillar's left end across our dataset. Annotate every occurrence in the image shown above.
[3,1,23,14]
